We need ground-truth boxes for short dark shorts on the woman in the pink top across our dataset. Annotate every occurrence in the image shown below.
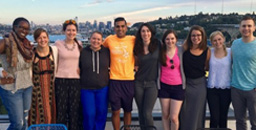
[158,82,185,100]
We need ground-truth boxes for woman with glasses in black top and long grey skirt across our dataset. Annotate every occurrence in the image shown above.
[181,25,211,130]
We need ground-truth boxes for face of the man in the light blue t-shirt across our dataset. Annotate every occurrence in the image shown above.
[239,20,255,37]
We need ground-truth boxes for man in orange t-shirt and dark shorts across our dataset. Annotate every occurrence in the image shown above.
[103,17,135,130]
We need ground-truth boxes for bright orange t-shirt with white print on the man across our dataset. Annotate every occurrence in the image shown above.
[103,35,135,80]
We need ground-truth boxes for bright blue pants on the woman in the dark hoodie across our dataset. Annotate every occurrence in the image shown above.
[81,86,108,130]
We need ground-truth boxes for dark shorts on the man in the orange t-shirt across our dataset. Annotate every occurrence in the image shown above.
[109,80,134,112]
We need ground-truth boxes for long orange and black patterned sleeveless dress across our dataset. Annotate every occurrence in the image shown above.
[28,48,56,125]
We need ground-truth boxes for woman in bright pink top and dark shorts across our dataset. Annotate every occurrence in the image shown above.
[158,30,185,130]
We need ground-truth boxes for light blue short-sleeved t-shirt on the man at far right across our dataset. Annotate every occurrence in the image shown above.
[231,38,256,91]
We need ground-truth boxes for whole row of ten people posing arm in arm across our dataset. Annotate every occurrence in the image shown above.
[0,16,256,130]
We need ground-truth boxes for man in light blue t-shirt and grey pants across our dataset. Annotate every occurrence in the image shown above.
[231,16,256,130]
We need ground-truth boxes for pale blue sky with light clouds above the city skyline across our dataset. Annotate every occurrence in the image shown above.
[0,0,256,25]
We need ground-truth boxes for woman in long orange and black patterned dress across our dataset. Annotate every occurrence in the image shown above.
[29,28,57,125]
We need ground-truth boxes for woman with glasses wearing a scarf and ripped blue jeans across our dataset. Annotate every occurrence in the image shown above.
[0,17,34,130]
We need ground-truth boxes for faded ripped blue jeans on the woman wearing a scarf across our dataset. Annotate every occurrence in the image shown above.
[0,87,32,130]
